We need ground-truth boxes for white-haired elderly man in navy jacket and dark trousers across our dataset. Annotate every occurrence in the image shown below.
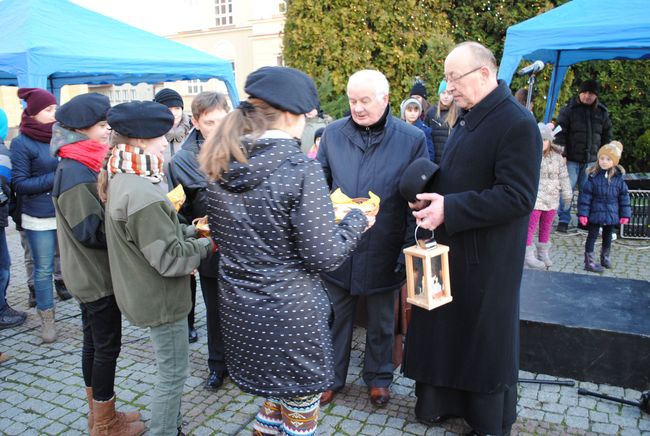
[317,70,428,406]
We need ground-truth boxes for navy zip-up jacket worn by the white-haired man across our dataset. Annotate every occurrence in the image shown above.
[317,109,429,295]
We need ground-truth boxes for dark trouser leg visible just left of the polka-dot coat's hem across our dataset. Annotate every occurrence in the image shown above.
[199,275,226,372]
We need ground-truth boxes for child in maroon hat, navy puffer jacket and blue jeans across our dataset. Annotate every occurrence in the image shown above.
[11,88,59,343]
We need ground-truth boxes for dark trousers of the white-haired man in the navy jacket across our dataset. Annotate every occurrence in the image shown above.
[324,282,397,391]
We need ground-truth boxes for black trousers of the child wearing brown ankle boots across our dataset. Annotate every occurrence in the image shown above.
[80,295,122,401]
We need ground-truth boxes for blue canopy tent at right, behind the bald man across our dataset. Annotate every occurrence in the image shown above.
[499,0,650,121]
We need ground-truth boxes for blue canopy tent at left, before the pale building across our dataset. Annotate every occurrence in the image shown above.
[0,0,239,105]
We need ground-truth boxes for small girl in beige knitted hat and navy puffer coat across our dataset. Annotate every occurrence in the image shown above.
[578,141,631,272]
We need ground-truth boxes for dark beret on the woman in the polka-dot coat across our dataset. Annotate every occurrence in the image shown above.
[244,67,318,115]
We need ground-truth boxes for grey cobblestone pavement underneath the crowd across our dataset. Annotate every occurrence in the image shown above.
[0,223,650,436]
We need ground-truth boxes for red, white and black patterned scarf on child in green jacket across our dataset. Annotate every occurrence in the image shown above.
[107,144,165,183]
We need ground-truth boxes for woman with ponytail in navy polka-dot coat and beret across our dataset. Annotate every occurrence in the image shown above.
[199,67,369,435]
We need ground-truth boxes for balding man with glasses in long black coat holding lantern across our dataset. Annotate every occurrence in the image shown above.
[404,42,542,434]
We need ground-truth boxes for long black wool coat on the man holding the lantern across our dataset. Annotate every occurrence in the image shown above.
[404,82,542,393]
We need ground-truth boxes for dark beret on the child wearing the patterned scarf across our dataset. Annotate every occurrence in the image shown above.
[107,101,174,139]
